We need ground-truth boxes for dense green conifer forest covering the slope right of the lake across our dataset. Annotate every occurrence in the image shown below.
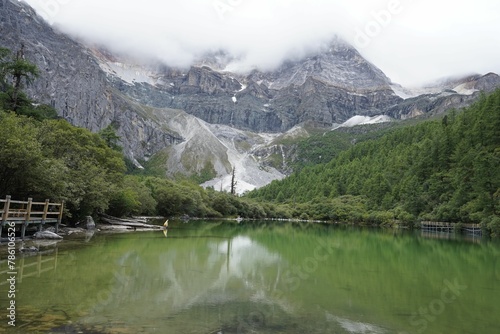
[248,91,500,233]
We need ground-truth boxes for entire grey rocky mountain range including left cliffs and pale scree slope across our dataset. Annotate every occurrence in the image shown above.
[0,0,500,190]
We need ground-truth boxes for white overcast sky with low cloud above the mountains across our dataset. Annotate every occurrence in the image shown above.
[25,0,500,86]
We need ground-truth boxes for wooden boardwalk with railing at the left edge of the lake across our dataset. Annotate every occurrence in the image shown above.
[0,196,64,241]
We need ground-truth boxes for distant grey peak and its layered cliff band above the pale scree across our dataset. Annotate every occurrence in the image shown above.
[95,38,402,132]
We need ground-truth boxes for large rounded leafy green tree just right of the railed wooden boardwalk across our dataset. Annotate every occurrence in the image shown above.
[38,120,125,218]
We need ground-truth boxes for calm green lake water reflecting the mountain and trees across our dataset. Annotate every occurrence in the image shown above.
[0,222,500,334]
